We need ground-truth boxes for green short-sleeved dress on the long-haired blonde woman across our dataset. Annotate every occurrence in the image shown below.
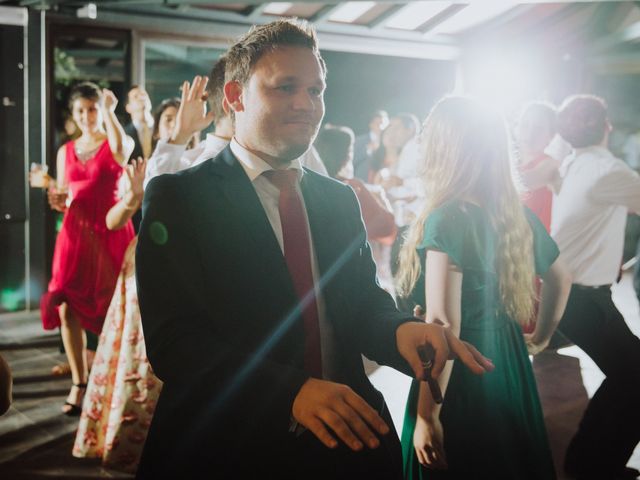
[402,201,558,480]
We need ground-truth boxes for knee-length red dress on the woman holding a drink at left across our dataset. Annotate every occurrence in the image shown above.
[40,140,134,334]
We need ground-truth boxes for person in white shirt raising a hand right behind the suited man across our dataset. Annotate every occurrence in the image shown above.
[144,56,327,187]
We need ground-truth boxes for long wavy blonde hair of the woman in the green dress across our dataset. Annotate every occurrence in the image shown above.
[396,96,535,324]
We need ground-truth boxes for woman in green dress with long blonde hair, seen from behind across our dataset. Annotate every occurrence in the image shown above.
[397,97,570,480]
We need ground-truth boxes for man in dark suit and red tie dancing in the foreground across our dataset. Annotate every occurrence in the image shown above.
[136,20,491,480]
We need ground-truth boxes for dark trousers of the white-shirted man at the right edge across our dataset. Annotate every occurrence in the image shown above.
[558,285,640,478]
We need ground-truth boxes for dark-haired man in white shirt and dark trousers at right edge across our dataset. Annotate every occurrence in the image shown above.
[551,95,640,479]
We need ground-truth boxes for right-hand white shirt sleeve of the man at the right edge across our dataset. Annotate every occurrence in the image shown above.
[589,160,640,213]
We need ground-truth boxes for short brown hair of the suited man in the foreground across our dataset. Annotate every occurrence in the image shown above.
[225,18,326,84]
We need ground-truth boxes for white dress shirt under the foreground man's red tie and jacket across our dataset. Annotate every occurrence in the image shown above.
[231,138,336,379]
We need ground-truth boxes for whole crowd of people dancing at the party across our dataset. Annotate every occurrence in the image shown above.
[15,15,640,480]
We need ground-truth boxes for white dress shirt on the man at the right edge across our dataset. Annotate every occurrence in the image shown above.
[551,146,640,286]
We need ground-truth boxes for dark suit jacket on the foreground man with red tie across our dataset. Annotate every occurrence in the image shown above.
[136,147,411,479]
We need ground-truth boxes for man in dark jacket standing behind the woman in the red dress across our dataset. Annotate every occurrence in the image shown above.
[124,85,153,159]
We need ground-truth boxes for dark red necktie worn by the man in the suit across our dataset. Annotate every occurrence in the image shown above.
[265,170,322,378]
